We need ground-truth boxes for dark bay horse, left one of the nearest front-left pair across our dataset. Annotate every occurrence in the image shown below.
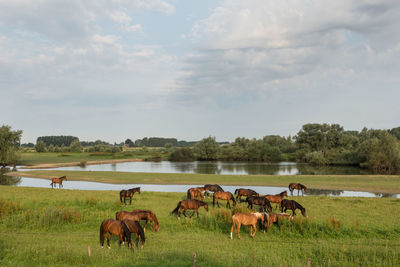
[100,219,132,248]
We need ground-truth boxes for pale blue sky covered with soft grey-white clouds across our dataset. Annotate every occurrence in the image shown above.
[0,0,400,143]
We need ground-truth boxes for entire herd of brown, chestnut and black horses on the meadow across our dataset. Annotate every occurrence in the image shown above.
[50,176,307,248]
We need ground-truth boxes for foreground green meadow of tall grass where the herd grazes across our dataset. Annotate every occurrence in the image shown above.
[0,186,400,266]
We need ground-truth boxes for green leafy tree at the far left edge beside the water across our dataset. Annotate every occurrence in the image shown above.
[0,125,22,168]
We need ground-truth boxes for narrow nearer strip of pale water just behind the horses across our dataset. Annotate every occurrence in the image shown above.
[0,177,400,198]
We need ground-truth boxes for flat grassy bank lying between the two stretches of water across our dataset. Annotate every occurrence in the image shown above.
[10,170,400,193]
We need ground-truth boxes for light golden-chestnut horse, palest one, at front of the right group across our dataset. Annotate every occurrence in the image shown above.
[231,212,267,239]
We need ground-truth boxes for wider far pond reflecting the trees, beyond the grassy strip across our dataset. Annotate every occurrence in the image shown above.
[18,161,369,175]
